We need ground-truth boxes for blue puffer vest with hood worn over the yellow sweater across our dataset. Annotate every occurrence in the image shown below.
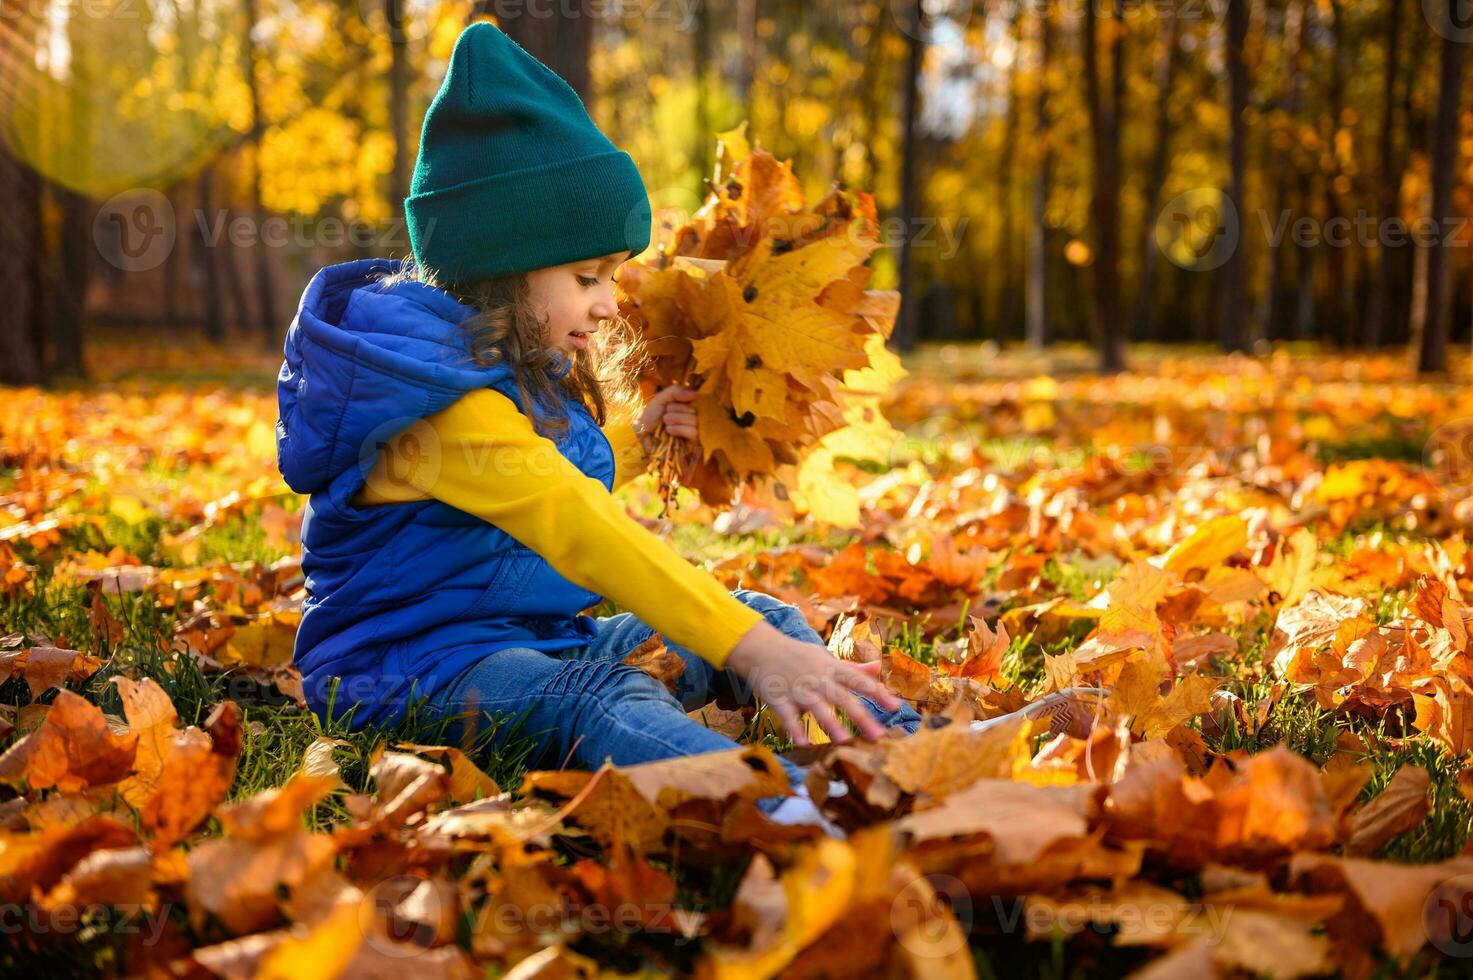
[277,259,614,728]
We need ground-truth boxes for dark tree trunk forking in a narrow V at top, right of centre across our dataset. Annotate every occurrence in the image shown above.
[1084,0,1125,373]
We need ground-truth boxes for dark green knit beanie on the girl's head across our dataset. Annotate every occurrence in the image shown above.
[404,22,651,281]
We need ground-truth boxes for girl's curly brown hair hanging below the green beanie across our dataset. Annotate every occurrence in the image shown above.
[380,259,647,441]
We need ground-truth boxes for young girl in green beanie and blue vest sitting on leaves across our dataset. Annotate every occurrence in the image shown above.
[277,24,919,819]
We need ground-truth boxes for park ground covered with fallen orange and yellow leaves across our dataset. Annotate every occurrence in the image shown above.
[0,346,1473,977]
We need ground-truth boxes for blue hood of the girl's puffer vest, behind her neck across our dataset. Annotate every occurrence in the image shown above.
[275,258,511,494]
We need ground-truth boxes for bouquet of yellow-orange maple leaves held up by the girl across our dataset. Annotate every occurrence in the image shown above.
[619,124,904,526]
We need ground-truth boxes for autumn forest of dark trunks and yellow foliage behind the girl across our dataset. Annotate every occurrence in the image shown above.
[0,0,1473,380]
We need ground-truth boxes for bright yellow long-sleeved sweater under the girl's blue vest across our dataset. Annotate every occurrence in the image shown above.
[344,388,762,666]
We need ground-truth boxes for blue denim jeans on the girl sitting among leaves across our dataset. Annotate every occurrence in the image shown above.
[429,589,921,800]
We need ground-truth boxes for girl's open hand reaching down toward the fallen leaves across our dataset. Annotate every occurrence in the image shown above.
[726,622,900,746]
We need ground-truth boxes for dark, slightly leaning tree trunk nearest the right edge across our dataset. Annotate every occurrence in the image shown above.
[1411,0,1464,374]
